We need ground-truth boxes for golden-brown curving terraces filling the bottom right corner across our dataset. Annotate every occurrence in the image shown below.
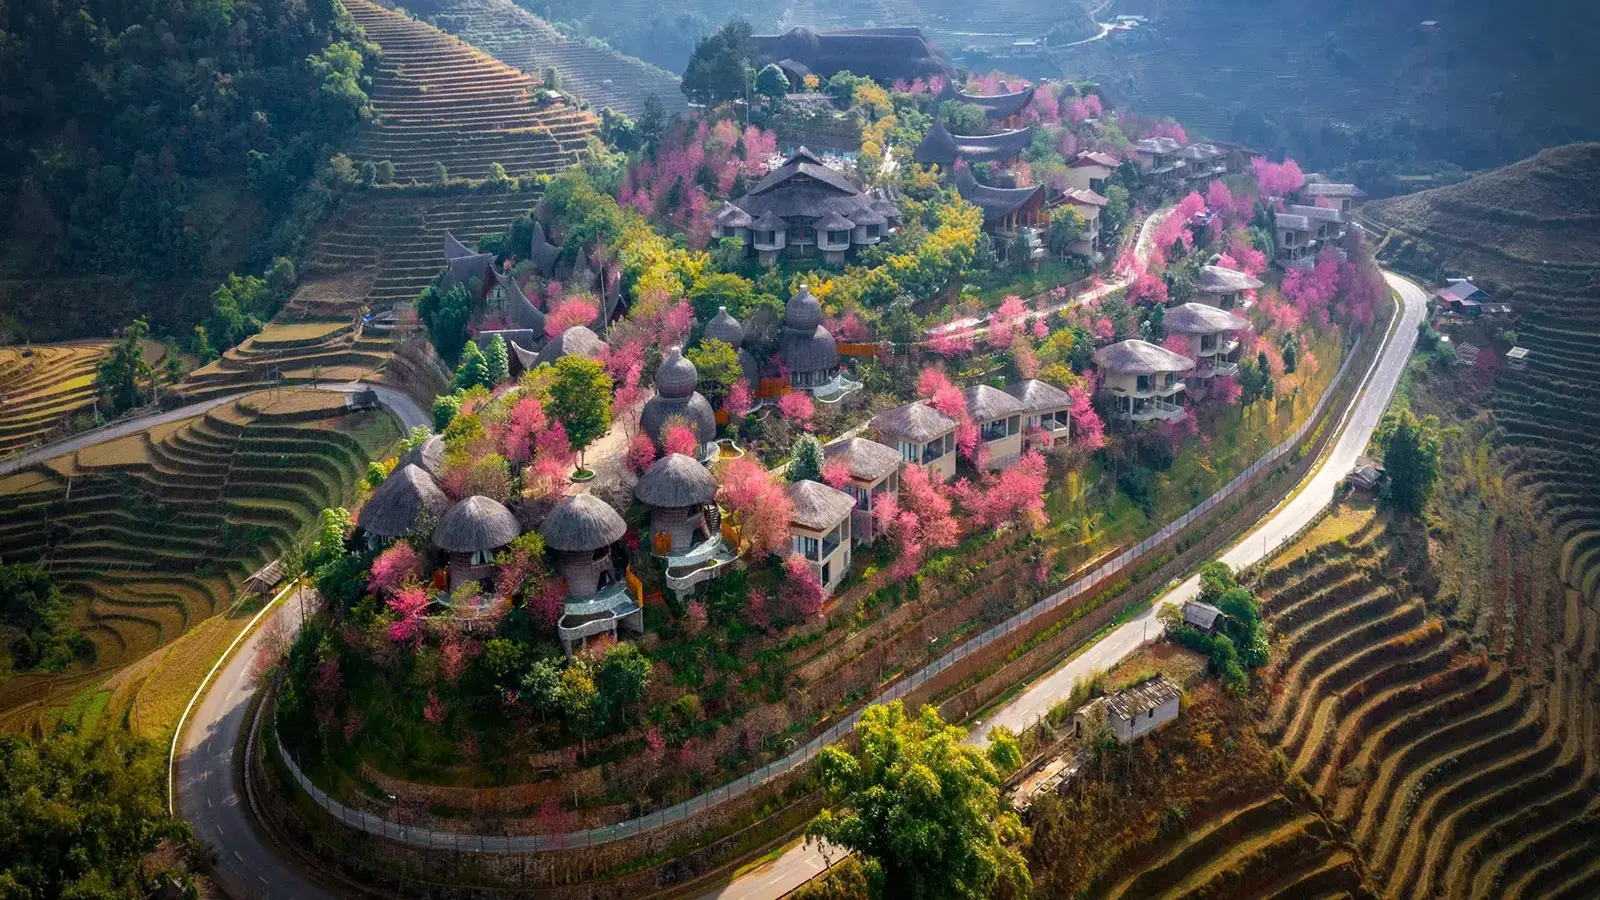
[1112,519,1600,898]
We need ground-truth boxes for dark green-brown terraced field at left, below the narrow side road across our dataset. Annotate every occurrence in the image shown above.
[0,391,398,709]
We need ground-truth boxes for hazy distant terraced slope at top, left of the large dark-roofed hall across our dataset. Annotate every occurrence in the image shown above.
[426,0,688,119]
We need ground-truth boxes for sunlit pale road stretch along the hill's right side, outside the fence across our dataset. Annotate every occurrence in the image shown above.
[699,272,1427,900]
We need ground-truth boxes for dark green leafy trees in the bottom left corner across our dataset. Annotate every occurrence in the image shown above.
[0,732,186,900]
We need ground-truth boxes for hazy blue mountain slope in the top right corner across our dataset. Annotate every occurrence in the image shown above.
[1058,0,1600,187]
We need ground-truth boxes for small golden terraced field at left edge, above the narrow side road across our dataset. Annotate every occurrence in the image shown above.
[0,341,152,456]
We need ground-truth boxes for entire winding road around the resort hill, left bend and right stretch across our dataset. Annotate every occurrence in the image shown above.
[156,274,1426,900]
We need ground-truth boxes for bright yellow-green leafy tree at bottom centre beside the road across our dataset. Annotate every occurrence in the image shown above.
[806,700,1032,900]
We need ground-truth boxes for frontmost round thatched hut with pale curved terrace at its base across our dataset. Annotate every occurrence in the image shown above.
[539,493,645,653]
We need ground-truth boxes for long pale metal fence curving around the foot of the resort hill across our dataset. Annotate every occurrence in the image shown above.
[277,338,1363,854]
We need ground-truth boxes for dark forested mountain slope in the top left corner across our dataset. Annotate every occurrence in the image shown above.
[0,0,366,340]
